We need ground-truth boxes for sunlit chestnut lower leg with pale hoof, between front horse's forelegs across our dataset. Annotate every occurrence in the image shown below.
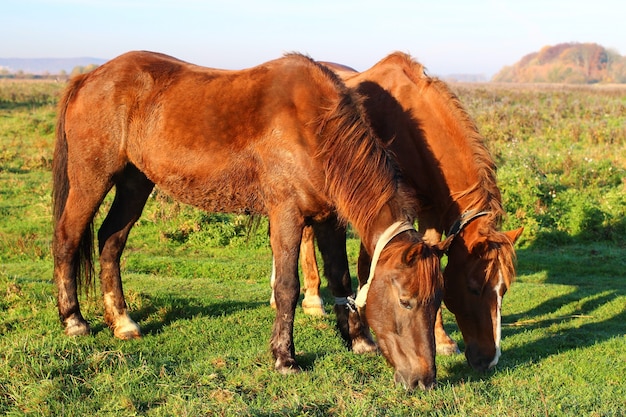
[300,226,326,316]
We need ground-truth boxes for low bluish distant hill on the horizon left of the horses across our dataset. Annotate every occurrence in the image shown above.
[0,57,107,75]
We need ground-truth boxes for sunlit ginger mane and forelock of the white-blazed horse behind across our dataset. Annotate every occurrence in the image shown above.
[380,52,516,287]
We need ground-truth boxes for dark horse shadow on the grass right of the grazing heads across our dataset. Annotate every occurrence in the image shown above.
[438,231,626,383]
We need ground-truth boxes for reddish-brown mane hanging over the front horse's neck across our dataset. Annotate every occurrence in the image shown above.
[304,55,412,236]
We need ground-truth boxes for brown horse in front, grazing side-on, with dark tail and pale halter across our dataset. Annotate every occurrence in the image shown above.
[53,52,449,388]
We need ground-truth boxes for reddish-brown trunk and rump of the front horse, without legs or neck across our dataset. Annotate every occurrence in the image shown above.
[63,52,341,213]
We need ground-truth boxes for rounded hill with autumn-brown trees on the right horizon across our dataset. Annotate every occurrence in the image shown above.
[491,43,626,84]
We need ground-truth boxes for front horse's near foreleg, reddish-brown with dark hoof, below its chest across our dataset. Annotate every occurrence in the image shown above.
[270,211,304,374]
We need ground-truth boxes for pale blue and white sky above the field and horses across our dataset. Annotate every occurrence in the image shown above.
[0,0,626,78]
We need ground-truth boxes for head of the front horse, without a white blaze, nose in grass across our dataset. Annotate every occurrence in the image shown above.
[357,226,451,390]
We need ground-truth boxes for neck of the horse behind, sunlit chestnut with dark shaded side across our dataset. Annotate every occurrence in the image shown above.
[372,68,499,229]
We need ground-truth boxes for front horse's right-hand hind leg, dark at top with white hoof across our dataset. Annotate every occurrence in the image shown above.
[98,165,154,340]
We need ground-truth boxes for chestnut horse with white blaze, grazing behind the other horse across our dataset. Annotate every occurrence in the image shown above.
[270,53,523,371]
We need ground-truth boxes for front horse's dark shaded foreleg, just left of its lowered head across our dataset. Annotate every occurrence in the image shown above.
[314,219,378,353]
